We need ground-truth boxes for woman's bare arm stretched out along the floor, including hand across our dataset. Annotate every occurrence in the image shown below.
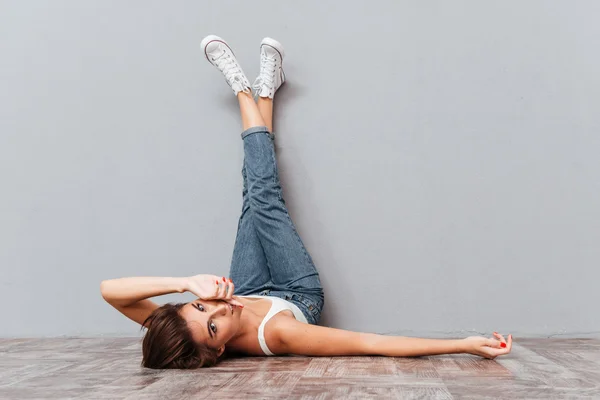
[273,320,512,358]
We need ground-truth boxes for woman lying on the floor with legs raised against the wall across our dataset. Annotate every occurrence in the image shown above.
[101,35,512,368]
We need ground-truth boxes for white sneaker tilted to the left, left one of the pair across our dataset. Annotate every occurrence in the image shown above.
[200,35,250,95]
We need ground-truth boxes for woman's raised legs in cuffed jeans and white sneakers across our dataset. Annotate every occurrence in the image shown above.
[211,36,323,306]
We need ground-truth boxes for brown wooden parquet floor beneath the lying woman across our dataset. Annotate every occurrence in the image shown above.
[0,338,600,400]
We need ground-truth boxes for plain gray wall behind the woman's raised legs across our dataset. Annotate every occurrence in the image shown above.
[0,0,600,337]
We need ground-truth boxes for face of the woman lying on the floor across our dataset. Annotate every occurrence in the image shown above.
[181,299,242,349]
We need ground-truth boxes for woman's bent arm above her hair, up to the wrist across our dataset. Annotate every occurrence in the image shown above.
[100,277,186,325]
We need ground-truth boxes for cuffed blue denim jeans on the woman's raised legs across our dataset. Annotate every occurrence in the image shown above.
[229,126,324,324]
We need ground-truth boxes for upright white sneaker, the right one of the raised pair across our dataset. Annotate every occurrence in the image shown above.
[252,38,285,99]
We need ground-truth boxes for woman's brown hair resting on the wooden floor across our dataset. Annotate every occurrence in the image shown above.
[142,303,219,369]
